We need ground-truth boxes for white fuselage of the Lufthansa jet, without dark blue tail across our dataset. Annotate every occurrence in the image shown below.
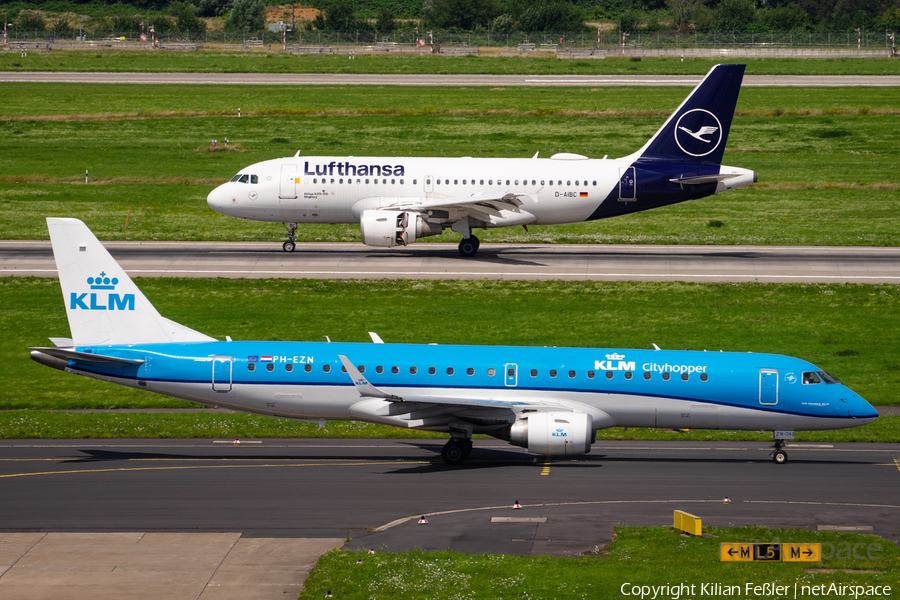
[208,154,753,227]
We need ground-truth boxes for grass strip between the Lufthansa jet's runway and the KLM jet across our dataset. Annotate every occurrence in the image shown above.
[7,278,900,414]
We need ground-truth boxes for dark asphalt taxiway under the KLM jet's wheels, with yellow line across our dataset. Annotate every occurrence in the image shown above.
[0,439,900,556]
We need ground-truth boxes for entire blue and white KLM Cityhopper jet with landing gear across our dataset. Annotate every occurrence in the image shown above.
[31,218,878,464]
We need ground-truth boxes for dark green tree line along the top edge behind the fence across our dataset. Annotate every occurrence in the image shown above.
[0,0,900,34]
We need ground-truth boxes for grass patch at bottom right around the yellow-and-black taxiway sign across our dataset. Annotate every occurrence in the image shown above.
[300,527,900,600]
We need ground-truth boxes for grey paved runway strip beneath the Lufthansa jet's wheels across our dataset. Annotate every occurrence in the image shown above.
[0,240,900,283]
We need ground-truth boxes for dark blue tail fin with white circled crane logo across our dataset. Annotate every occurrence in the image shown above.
[632,65,745,165]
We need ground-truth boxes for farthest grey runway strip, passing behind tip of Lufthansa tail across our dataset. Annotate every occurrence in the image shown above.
[0,71,900,87]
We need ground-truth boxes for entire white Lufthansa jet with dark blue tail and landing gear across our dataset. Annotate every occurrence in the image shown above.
[207,65,756,256]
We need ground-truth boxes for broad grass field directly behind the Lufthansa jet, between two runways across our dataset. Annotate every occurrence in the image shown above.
[0,84,900,246]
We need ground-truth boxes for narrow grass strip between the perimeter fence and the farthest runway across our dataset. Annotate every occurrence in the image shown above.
[0,50,900,75]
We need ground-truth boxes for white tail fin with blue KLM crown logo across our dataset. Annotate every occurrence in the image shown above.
[47,217,214,346]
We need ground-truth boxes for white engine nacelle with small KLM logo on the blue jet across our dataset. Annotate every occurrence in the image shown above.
[509,412,593,456]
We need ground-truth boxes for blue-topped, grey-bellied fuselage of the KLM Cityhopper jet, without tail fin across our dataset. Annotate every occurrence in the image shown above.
[69,342,878,433]
